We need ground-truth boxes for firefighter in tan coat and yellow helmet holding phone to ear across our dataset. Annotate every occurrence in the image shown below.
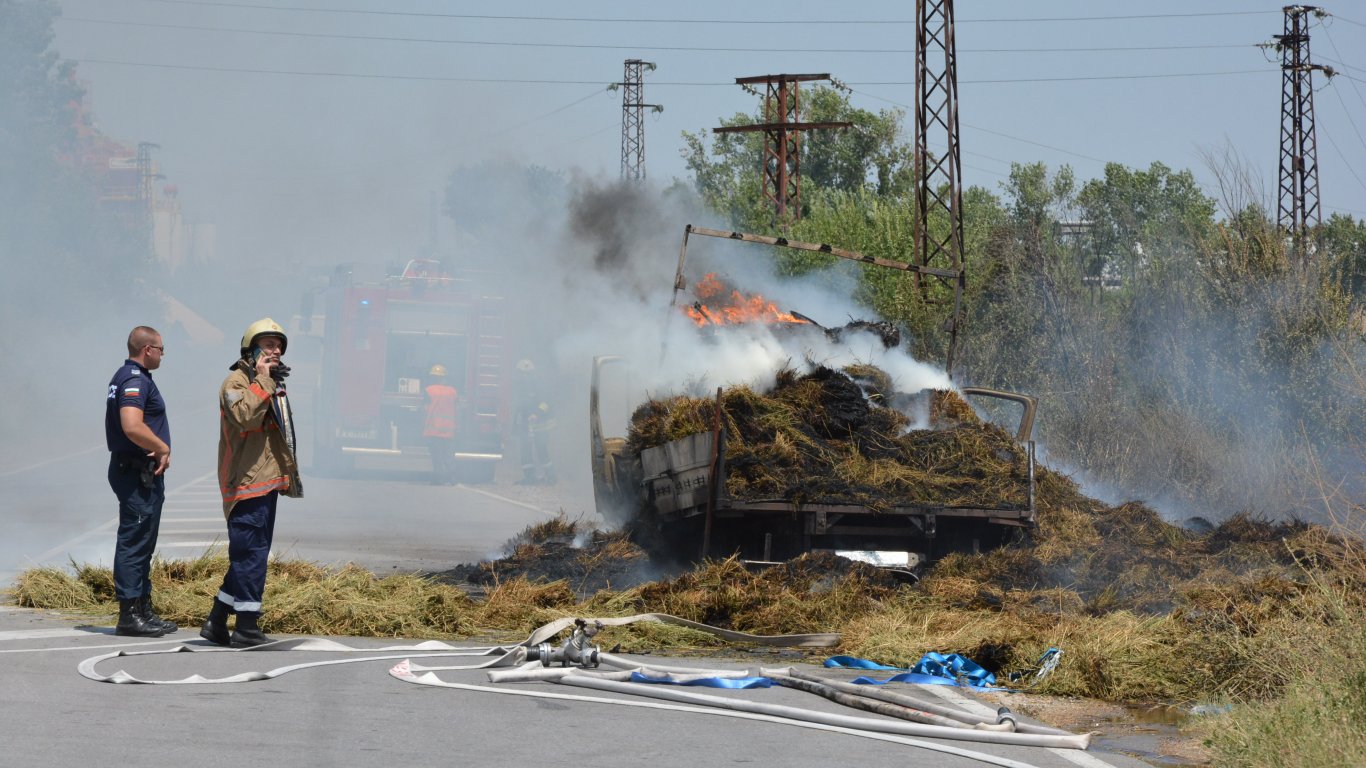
[199,317,303,646]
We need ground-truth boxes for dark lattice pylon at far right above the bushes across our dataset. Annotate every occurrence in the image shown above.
[1274,5,1333,258]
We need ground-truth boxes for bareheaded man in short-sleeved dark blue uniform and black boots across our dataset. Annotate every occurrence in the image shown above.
[104,325,178,637]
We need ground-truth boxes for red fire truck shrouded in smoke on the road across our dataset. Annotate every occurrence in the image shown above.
[305,260,510,482]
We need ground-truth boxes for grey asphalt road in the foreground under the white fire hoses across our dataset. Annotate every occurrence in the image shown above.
[0,608,1143,768]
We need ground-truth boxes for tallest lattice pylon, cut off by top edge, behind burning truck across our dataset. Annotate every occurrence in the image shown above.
[915,0,967,376]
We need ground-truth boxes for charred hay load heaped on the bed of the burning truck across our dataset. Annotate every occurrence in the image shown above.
[627,365,1027,510]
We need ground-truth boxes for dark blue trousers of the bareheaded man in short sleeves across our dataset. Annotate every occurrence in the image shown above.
[109,454,167,600]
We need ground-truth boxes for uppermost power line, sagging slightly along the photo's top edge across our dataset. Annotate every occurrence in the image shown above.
[122,0,1273,26]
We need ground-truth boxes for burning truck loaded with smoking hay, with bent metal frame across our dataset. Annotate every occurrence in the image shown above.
[589,227,1037,574]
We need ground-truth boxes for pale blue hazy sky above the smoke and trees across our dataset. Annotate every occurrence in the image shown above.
[48,0,1366,262]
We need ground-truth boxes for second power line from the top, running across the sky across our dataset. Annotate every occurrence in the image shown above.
[59,16,1254,53]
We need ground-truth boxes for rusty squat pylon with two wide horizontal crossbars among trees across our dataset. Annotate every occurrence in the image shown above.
[712,74,852,223]
